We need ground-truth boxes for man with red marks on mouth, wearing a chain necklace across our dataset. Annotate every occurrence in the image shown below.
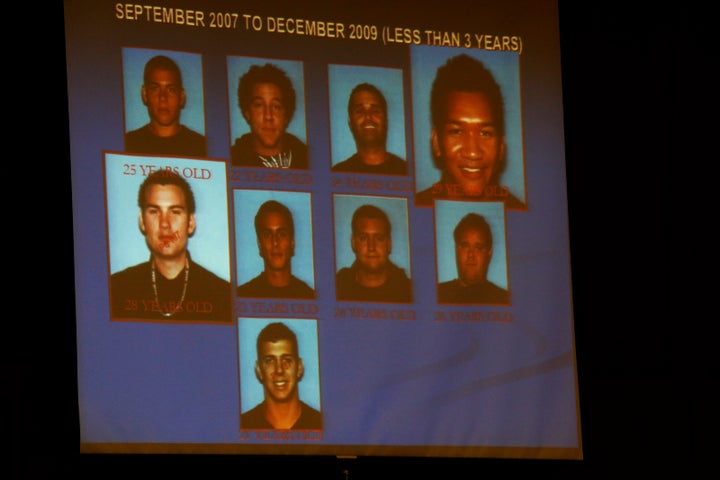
[110,170,232,323]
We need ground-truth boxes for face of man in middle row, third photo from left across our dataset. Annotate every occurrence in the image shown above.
[351,217,392,273]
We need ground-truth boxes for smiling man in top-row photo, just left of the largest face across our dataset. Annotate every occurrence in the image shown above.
[332,83,407,175]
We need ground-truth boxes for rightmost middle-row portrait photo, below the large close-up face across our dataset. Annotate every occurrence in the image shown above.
[433,200,510,305]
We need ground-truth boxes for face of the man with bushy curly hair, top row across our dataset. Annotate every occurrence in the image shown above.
[243,83,290,155]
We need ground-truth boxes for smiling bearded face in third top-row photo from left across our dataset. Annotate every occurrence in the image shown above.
[348,90,387,147]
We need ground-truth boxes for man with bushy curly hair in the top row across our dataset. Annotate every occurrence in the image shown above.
[230,63,309,170]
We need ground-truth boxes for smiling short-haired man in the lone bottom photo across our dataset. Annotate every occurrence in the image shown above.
[240,322,322,430]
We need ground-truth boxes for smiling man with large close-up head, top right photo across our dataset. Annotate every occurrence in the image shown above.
[415,54,525,209]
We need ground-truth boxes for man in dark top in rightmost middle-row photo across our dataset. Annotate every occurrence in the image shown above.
[437,213,510,305]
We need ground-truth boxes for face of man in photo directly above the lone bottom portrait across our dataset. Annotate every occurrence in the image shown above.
[257,212,295,270]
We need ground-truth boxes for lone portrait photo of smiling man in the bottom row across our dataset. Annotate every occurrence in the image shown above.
[238,317,323,430]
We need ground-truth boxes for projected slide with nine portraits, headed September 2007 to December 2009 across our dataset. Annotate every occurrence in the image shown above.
[65,0,583,459]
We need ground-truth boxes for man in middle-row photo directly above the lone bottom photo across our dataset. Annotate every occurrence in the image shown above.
[237,200,315,299]
